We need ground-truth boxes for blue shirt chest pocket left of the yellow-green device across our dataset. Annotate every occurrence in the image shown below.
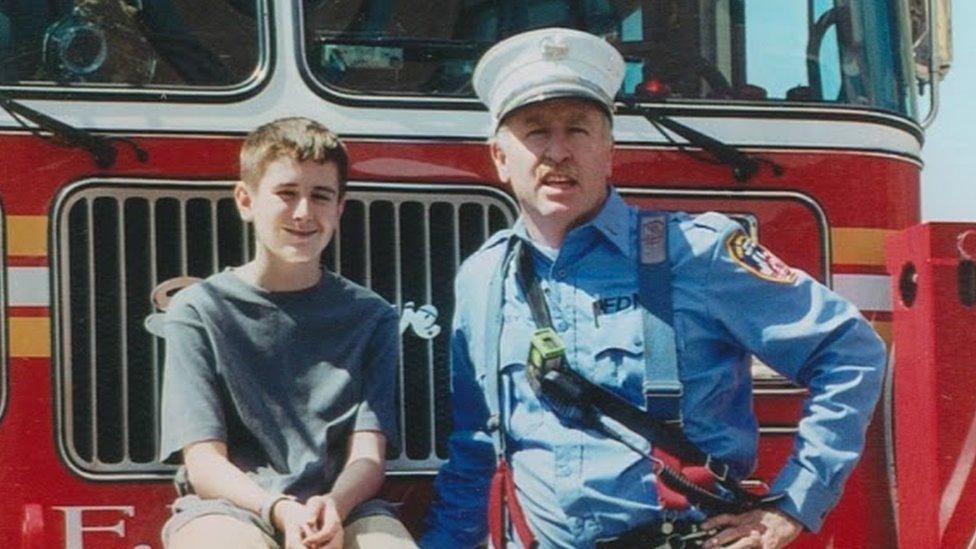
[499,326,544,441]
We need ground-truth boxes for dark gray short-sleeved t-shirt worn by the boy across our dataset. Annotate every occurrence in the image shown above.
[160,271,399,498]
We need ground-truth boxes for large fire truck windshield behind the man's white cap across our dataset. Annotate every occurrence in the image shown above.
[304,0,916,117]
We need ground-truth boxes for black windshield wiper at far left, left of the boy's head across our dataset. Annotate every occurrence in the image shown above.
[0,93,149,170]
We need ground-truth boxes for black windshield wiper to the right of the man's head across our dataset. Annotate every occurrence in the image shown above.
[617,96,783,182]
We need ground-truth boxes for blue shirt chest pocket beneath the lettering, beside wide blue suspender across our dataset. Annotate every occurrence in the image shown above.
[589,311,644,401]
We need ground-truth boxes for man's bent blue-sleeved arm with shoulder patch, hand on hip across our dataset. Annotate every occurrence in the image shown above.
[692,216,885,531]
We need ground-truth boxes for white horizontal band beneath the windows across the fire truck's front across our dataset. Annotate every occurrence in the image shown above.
[0,100,921,157]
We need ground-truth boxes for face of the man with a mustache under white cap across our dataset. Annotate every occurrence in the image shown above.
[491,99,613,229]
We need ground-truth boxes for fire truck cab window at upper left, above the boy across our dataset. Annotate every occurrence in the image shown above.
[0,0,270,97]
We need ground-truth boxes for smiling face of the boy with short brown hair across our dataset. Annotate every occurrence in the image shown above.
[234,157,345,267]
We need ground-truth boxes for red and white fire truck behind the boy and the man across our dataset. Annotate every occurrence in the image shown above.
[0,0,964,549]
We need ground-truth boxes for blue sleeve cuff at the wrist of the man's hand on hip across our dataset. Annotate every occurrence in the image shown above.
[772,460,839,532]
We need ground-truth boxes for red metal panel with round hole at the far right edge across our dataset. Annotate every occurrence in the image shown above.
[887,223,976,547]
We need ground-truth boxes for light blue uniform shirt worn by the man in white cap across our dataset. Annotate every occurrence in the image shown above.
[421,191,885,548]
